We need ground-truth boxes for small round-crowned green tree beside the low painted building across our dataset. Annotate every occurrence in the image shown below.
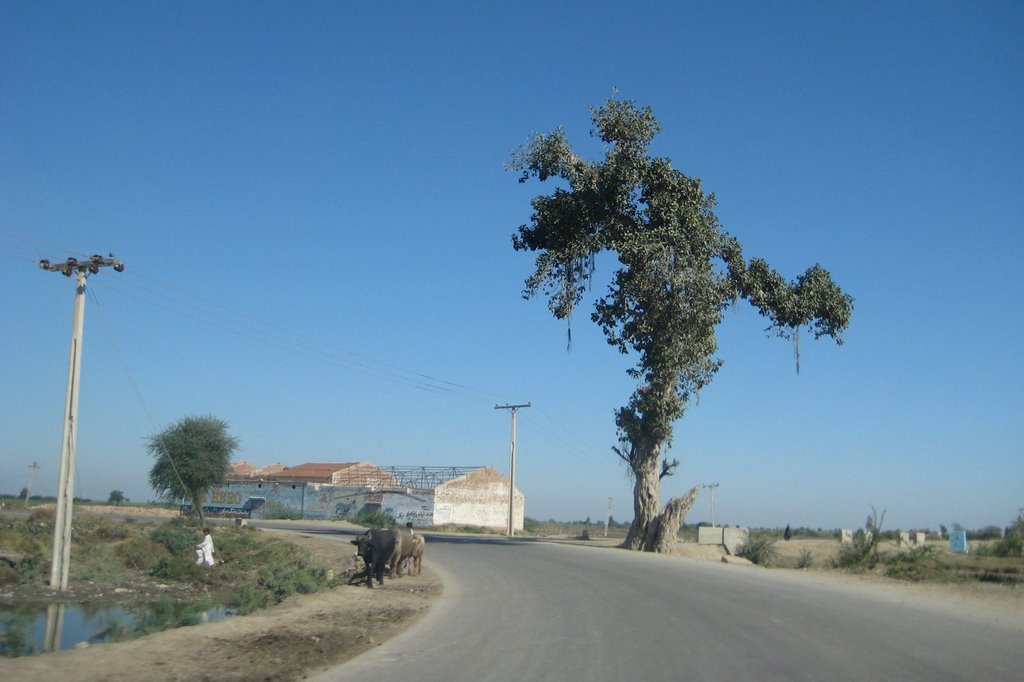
[147,416,239,523]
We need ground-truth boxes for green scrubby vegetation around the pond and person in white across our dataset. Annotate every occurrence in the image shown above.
[0,509,337,655]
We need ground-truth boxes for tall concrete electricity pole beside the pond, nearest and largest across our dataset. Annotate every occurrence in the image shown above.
[39,254,125,592]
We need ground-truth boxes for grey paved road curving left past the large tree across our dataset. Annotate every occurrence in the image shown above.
[310,536,1024,682]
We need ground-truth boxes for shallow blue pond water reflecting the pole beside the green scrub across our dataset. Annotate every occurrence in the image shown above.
[0,600,231,656]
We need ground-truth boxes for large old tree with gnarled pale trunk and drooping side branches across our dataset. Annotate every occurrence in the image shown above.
[509,99,853,552]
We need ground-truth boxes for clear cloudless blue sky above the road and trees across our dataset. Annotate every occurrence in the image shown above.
[0,1,1024,528]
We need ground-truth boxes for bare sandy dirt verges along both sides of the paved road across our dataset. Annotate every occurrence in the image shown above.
[0,520,1024,682]
